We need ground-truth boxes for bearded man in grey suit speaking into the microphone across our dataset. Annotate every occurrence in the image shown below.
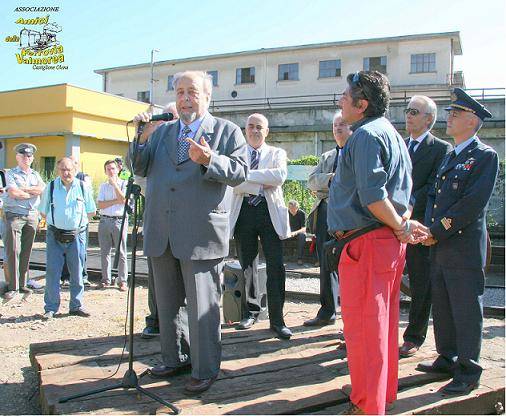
[131,71,247,393]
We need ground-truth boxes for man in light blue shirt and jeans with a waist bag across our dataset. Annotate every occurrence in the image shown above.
[39,157,96,319]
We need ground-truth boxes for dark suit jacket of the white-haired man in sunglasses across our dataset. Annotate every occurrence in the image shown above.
[406,133,452,221]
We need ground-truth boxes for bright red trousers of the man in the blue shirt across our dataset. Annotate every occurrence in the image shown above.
[339,227,406,415]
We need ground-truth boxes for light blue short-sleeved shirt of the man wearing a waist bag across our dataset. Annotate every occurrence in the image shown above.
[39,177,97,230]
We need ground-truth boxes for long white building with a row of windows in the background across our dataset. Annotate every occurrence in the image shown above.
[95,32,464,110]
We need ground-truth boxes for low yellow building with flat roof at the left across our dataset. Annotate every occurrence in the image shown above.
[0,84,148,183]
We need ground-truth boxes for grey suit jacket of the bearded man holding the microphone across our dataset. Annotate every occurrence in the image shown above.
[130,113,248,260]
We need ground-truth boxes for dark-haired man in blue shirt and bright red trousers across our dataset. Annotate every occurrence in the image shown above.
[327,71,420,414]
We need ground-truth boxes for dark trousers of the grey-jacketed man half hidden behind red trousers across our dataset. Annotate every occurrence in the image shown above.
[316,201,339,319]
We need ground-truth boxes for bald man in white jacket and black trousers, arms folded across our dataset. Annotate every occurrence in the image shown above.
[230,114,292,339]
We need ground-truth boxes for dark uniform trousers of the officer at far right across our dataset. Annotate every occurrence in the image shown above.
[431,261,485,383]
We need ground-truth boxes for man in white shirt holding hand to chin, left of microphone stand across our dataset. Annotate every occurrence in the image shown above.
[98,160,128,292]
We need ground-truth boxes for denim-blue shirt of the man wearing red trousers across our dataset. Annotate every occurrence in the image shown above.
[327,117,413,233]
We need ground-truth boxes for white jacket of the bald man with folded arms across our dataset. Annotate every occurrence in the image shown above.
[230,144,290,239]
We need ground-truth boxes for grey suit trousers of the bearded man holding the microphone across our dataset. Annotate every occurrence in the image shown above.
[151,244,223,380]
